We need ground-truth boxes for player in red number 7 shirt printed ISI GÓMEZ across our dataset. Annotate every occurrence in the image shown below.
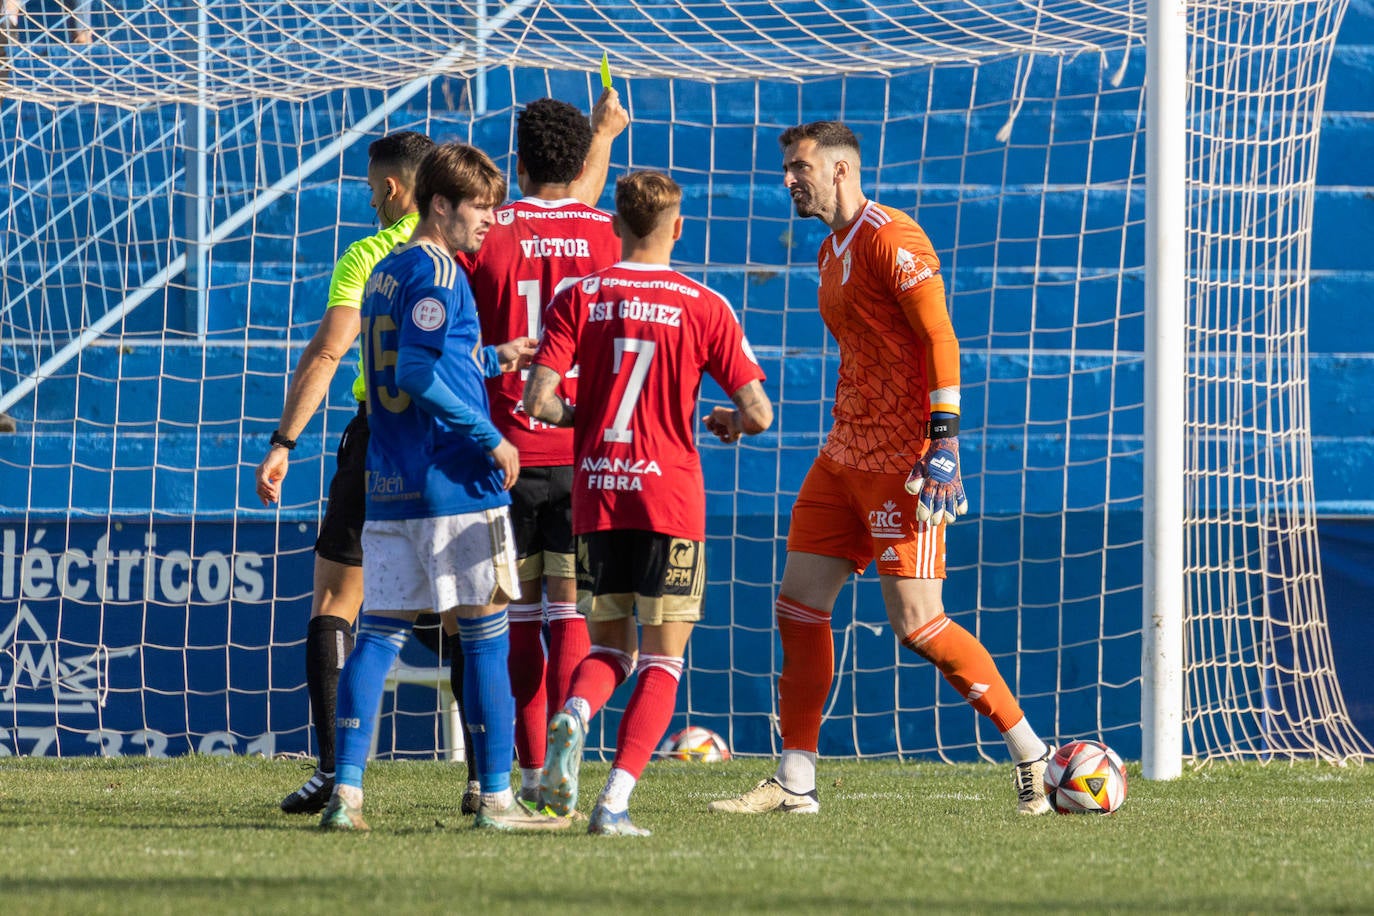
[525,172,772,836]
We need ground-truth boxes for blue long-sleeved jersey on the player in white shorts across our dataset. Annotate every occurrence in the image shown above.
[361,242,510,519]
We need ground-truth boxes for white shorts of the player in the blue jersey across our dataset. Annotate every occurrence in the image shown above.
[363,505,518,615]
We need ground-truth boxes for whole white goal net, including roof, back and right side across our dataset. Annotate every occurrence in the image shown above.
[0,0,1374,761]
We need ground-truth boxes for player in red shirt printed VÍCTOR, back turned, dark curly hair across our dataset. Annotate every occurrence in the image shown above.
[466,89,628,802]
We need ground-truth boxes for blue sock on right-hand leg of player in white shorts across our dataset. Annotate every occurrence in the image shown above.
[456,610,515,792]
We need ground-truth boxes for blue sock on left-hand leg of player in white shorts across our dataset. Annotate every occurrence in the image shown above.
[334,614,406,788]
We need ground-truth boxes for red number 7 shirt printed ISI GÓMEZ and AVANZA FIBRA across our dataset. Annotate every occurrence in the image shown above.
[534,240,764,541]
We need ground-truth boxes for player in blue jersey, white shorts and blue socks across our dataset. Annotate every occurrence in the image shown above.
[320,143,567,831]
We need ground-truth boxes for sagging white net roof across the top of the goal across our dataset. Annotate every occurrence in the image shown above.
[10,0,1145,107]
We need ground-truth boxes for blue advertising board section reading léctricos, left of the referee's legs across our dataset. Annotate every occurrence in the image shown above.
[0,519,313,757]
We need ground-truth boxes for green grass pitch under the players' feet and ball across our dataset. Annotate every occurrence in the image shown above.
[0,757,1374,915]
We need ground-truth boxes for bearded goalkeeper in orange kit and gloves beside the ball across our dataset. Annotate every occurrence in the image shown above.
[709,121,1050,814]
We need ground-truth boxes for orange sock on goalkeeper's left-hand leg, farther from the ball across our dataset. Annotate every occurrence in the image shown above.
[774,595,835,753]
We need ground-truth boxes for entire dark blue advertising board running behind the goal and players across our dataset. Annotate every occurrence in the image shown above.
[8,514,1374,759]
